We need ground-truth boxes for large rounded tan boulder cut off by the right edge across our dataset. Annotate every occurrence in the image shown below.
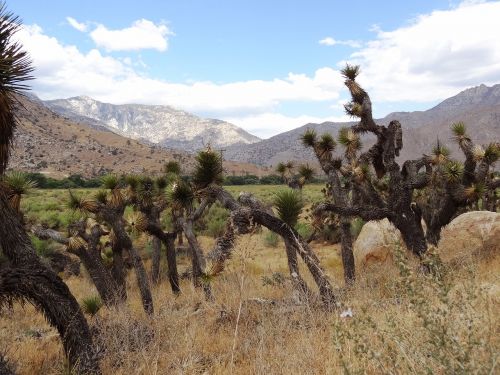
[438,211,500,262]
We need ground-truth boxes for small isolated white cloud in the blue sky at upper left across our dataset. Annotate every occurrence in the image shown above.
[90,19,172,51]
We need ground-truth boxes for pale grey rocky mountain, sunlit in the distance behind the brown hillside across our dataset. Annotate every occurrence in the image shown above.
[44,96,260,152]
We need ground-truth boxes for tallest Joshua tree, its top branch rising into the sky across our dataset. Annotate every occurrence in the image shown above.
[303,65,432,257]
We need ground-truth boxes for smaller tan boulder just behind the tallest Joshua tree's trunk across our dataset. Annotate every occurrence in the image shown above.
[353,219,402,269]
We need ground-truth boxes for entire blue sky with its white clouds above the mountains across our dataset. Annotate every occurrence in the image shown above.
[8,0,500,138]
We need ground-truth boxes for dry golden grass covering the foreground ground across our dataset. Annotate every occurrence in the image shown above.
[0,234,500,374]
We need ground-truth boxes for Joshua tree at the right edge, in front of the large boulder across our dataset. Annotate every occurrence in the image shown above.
[418,129,500,245]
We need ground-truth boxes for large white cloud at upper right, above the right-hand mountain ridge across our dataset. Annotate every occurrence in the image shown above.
[352,1,500,102]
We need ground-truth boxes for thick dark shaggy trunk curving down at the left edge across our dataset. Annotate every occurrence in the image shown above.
[0,192,100,374]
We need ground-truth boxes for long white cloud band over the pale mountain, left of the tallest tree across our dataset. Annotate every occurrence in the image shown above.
[14,25,343,117]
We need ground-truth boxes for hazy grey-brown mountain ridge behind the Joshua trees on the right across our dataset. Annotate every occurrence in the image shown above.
[226,84,500,166]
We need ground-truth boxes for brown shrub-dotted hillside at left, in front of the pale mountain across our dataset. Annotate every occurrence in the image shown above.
[9,95,265,178]
